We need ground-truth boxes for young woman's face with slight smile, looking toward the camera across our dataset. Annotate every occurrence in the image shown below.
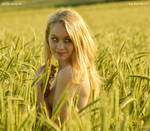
[48,23,74,61]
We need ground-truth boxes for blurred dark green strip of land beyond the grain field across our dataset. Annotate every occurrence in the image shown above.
[0,0,147,8]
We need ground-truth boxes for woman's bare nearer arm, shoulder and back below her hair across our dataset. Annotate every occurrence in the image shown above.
[53,66,90,123]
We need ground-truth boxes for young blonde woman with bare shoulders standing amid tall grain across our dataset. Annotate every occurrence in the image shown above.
[35,9,100,122]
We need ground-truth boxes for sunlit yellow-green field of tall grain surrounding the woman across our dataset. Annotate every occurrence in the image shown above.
[0,1,150,131]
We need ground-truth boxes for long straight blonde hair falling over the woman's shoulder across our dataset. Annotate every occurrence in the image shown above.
[45,9,100,97]
